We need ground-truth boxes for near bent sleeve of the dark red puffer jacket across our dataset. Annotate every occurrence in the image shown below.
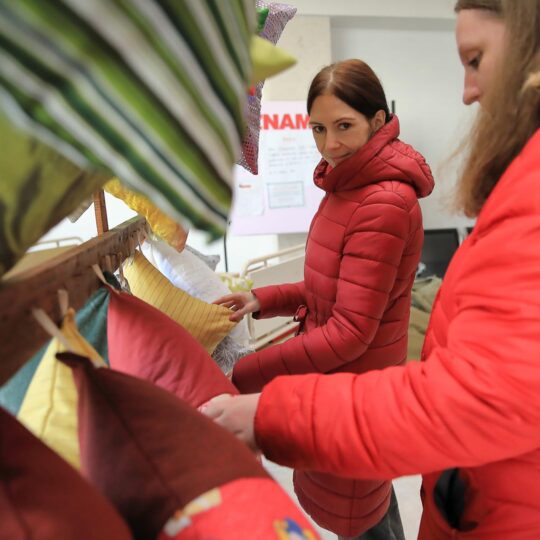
[233,191,412,393]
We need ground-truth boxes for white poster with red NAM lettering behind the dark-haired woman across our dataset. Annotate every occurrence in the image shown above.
[229,101,323,235]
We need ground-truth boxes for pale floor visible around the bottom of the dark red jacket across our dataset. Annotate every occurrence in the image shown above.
[264,460,422,540]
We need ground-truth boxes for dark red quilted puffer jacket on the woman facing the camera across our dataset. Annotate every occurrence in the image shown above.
[233,116,433,537]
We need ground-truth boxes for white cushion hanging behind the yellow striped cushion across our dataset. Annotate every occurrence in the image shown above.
[141,239,249,347]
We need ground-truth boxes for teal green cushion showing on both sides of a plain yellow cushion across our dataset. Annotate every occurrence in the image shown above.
[0,288,110,416]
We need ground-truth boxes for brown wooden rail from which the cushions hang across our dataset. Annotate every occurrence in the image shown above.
[0,217,146,385]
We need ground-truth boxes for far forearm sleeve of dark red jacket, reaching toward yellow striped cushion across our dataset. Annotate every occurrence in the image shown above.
[251,281,305,319]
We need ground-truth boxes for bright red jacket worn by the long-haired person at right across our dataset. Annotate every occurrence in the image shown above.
[255,130,540,540]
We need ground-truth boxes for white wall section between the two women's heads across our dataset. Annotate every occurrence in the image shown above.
[332,17,474,229]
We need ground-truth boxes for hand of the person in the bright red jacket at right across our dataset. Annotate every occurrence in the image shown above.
[201,394,260,452]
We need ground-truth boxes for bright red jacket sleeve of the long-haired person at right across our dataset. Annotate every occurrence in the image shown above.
[255,201,540,479]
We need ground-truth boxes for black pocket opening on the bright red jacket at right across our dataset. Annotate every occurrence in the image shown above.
[433,468,478,532]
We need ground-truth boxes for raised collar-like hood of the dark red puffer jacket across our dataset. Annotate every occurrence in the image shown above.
[313,115,435,197]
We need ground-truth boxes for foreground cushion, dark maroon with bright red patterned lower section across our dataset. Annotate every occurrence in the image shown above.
[60,353,316,540]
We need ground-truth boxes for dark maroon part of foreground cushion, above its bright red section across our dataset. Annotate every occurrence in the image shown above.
[58,352,266,540]
